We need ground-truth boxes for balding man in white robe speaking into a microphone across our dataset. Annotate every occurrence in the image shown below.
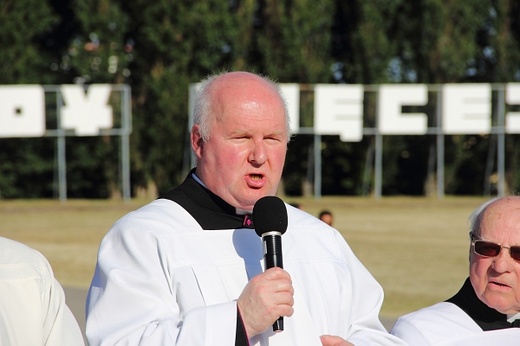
[86,72,404,346]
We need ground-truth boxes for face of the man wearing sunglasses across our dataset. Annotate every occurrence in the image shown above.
[470,197,520,314]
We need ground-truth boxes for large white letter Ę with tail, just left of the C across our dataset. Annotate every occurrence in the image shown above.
[314,84,363,142]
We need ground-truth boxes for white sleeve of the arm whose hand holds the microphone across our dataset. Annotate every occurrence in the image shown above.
[86,220,237,346]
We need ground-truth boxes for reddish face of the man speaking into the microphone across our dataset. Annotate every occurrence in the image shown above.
[192,74,288,210]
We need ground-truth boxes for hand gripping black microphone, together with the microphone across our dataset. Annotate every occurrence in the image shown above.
[238,196,294,337]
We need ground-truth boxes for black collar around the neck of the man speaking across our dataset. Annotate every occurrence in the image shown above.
[159,169,254,230]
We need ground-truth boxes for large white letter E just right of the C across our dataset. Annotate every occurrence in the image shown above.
[442,84,491,134]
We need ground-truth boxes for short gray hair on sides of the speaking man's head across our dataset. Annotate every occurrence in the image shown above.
[193,72,291,142]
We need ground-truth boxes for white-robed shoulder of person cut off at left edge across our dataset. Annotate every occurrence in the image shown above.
[0,237,85,346]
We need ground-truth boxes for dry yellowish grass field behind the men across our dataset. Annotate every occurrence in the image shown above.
[0,197,485,317]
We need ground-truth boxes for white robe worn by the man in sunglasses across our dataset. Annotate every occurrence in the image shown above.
[391,302,520,346]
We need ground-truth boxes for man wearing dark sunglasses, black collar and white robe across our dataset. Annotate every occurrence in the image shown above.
[391,196,520,346]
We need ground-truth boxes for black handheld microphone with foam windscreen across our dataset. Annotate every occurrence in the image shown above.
[253,196,287,332]
